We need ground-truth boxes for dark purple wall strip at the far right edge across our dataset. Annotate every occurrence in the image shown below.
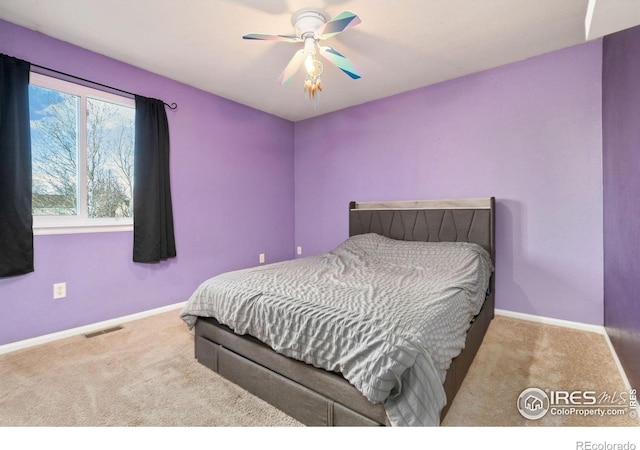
[602,27,640,388]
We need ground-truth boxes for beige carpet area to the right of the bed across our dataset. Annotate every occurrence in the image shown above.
[443,316,640,427]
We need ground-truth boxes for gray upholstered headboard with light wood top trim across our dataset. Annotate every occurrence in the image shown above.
[349,197,495,264]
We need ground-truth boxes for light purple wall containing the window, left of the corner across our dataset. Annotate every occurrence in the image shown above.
[0,21,294,345]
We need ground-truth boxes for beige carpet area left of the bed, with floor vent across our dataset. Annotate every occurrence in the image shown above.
[0,312,297,426]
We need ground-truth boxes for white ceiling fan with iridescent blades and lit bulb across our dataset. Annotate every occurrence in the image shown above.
[242,8,361,104]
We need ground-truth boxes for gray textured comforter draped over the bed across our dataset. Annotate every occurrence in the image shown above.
[182,234,493,426]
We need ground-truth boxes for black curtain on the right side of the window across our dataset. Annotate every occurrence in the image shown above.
[133,95,176,263]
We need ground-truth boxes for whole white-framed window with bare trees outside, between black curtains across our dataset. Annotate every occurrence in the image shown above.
[29,73,135,234]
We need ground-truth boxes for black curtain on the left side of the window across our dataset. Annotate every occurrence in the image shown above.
[0,54,33,277]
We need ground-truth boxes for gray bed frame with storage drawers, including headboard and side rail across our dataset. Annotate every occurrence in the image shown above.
[195,197,495,426]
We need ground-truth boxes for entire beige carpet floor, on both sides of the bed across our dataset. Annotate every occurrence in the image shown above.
[0,311,640,427]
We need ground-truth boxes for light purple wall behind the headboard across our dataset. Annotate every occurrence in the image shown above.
[295,41,603,325]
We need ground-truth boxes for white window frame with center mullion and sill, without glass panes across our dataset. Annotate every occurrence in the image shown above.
[29,71,135,235]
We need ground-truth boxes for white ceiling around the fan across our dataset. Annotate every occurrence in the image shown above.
[0,0,640,121]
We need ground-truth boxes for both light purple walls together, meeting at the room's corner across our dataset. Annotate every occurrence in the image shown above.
[0,17,603,345]
